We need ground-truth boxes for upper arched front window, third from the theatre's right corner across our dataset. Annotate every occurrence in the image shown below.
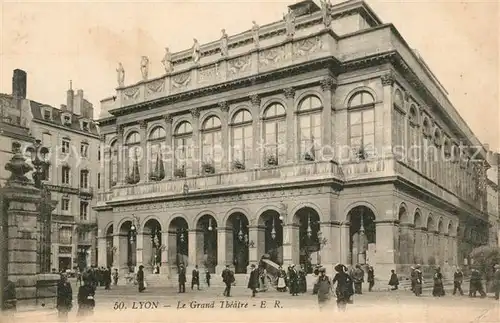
[264,103,286,166]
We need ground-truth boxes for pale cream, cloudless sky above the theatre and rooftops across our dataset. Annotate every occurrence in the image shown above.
[0,0,500,151]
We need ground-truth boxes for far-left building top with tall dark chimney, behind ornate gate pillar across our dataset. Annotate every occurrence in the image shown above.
[0,70,35,186]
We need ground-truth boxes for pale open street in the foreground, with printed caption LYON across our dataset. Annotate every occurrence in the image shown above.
[11,285,500,323]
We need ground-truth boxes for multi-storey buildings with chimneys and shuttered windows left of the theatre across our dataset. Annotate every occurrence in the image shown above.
[0,70,100,270]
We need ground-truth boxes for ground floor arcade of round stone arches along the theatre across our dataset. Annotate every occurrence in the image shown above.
[98,185,484,275]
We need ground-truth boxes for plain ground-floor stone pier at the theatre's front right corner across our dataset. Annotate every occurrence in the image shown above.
[375,220,397,273]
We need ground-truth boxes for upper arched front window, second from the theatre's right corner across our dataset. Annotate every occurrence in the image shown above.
[297,95,323,161]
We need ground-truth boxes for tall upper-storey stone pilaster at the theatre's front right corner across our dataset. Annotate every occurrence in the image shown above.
[375,71,395,159]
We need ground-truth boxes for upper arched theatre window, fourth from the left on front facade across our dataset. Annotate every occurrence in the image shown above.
[174,121,193,177]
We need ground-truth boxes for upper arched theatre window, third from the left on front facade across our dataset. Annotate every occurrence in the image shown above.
[148,126,167,180]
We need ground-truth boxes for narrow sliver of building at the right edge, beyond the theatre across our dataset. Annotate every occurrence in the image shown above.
[487,152,500,247]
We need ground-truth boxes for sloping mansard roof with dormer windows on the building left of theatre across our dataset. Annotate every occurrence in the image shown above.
[30,100,99,136]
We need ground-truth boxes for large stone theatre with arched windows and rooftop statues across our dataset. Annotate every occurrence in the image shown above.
[96,1,488,275]
